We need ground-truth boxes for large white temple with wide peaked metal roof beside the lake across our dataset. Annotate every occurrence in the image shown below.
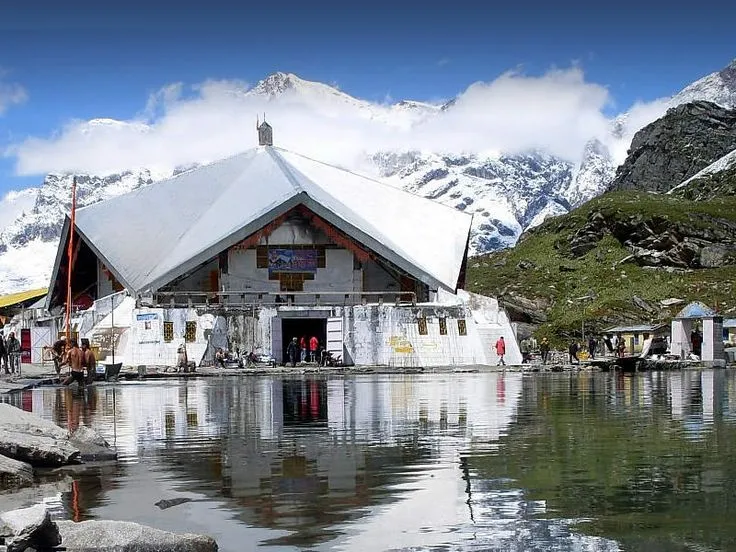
[46,132,521,366]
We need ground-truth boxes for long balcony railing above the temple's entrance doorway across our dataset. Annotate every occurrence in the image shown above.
[147,291,417,310]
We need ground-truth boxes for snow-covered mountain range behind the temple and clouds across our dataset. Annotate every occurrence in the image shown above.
[0,60,736,293]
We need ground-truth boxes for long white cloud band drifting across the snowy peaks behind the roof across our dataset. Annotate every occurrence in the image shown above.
[1,67,660,175]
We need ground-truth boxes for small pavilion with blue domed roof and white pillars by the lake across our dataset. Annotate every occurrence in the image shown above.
[672,301,725,363]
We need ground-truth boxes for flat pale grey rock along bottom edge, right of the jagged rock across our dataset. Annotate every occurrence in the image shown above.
[57,521,217,552]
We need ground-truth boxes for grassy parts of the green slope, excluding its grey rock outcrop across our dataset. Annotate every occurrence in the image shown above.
[468,192,736,338]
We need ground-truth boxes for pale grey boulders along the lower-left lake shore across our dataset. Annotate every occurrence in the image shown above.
[0,403,217,552]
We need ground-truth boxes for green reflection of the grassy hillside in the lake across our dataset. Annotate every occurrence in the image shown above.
[469,370,736,552]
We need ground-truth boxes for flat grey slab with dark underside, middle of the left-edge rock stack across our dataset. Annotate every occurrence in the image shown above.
[0,428,79,467]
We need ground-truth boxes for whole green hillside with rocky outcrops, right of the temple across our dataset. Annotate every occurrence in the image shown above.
[468,191,736,339]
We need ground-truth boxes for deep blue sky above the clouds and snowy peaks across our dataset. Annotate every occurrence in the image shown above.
[0,0,736,194]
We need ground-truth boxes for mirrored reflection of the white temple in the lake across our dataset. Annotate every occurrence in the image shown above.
[0,374,522,543]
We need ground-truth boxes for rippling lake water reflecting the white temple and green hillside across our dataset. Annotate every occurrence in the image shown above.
[0,370,736,552]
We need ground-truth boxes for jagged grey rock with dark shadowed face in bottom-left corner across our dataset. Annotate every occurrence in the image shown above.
[0,504,61,552]
